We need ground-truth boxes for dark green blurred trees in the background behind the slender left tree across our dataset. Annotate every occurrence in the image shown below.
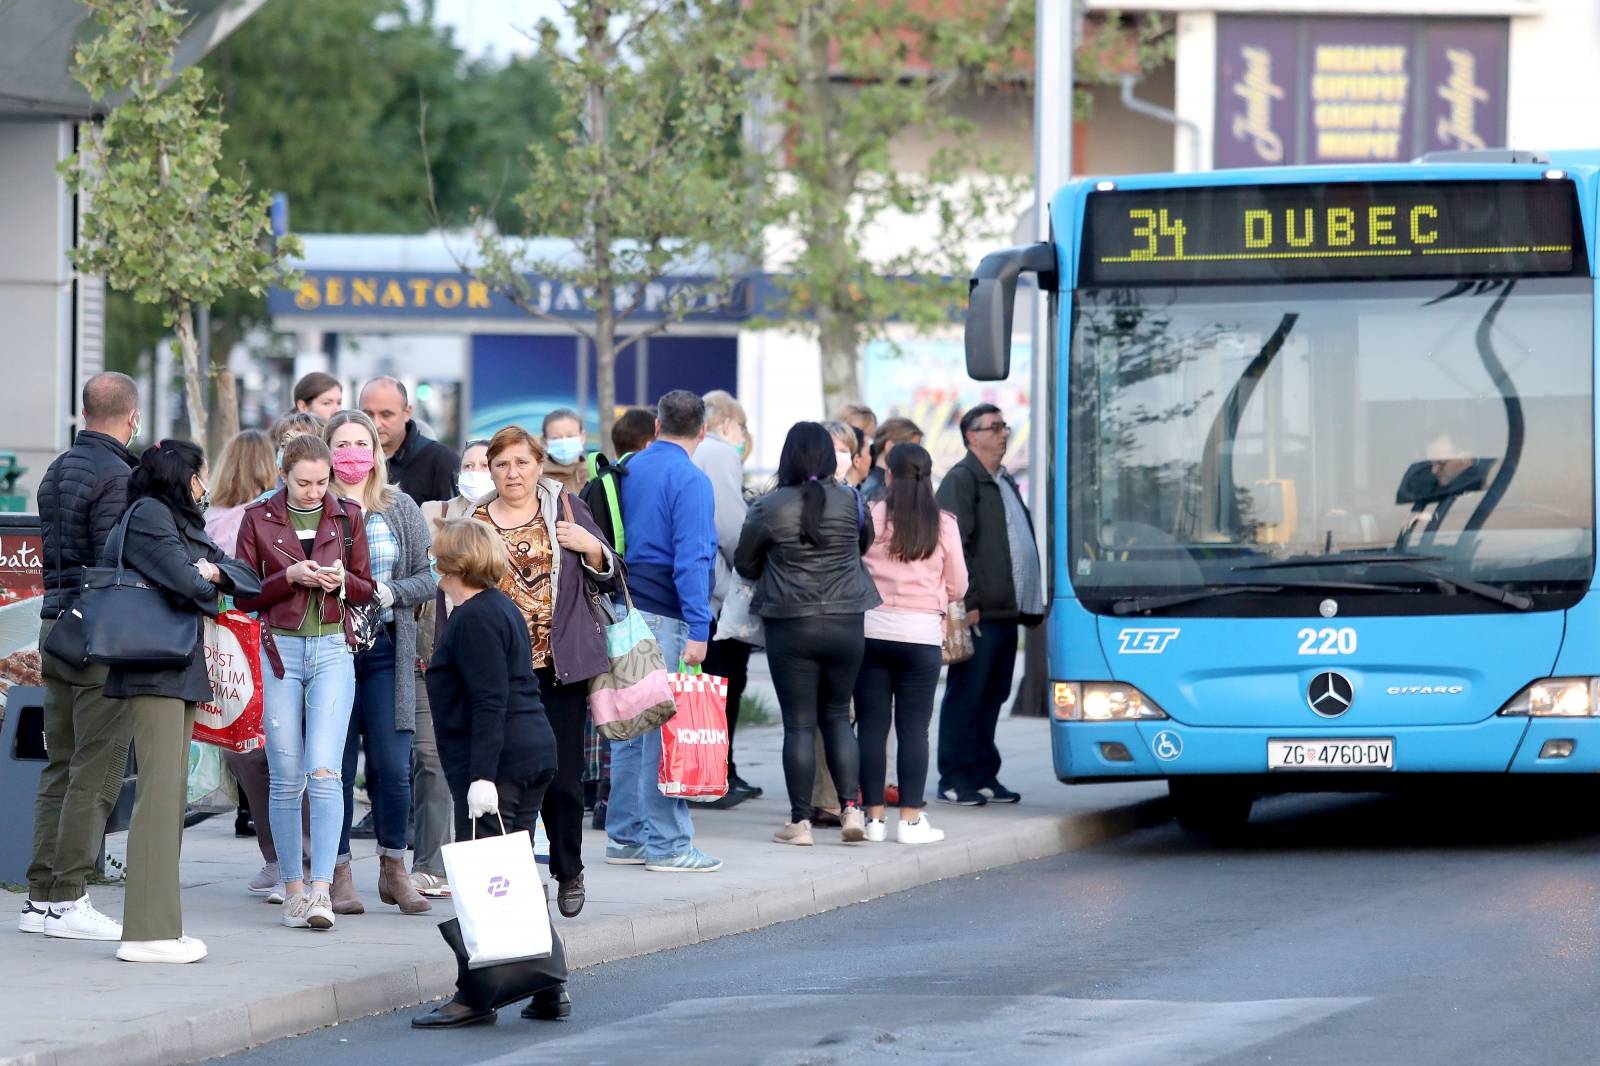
[106,0,555,435]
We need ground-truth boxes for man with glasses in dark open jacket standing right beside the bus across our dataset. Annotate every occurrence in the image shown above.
[938,403,1045,807]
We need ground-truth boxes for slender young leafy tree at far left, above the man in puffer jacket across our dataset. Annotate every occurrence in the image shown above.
[61,0,298,442]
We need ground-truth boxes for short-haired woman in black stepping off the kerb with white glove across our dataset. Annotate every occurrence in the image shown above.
[411,519,571,1029]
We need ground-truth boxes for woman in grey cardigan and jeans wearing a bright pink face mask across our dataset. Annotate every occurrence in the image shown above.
[323,411,435,914]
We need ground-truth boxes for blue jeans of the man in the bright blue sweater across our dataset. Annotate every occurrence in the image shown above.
[605,608,694,863]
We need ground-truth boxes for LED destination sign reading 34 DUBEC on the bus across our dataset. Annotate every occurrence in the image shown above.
[1078,181,1587,288]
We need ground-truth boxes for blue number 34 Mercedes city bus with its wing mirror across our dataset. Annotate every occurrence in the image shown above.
[966,150,1600,832]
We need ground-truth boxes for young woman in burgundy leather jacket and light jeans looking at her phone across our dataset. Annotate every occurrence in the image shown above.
[238,437,373,930]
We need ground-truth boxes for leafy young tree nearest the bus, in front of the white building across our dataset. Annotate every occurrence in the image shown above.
[750,0,1034,410]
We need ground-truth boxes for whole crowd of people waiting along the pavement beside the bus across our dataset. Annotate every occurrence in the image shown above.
[19,373,1045,1028]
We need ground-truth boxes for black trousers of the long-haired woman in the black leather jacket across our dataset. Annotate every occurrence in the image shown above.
[766,615,866,821]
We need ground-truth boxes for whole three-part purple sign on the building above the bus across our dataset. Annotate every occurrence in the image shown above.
[1213,14,1509,168]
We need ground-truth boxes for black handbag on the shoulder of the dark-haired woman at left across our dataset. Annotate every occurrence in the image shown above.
[75,499,200,671]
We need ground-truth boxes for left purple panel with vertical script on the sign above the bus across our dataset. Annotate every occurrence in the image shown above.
[1213,18,1299,166]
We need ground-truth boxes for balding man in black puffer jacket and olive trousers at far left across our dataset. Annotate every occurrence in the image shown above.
[18,373,139,940]
